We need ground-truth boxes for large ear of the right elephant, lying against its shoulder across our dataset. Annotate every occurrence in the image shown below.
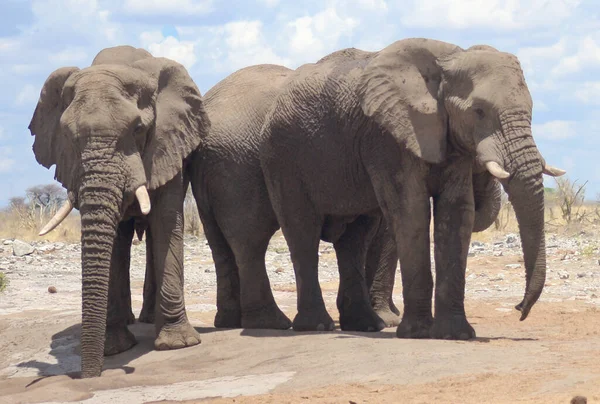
[358,39,457,163]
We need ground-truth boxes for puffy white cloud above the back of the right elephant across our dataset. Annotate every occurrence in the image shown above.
[287,7,358,64]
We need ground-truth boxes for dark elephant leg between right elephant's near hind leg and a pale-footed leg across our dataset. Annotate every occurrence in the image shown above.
[334,215,385,331]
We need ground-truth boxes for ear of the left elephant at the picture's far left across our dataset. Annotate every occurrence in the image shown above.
[29,67,79,190]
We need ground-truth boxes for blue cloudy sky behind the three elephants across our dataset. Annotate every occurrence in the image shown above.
[0,0,600,206]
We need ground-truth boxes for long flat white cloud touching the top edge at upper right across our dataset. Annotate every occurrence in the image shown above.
[401,0,580,31]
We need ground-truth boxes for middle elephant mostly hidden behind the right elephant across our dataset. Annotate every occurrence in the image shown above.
[140,65,500,331]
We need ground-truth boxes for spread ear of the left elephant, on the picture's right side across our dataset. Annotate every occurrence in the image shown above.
[132,57,210,190]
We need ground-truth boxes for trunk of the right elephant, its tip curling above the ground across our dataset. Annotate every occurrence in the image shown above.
[500,114,546,321]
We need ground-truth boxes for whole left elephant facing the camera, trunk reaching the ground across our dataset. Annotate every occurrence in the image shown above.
[29,46,210,378]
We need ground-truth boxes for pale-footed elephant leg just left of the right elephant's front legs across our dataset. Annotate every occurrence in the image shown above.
[365,218,400,327]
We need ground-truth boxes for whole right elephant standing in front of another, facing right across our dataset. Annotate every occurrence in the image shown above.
[255,38,564,340]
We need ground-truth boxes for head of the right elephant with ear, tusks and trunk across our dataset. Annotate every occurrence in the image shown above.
[358,39,564,320]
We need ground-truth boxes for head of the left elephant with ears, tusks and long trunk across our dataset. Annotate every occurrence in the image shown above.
[29,46,210,377]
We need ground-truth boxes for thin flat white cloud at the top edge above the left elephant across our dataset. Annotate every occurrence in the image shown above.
[124,0,213,16]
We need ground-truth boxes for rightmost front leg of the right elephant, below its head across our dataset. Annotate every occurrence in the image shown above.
[431,161,475,340]
